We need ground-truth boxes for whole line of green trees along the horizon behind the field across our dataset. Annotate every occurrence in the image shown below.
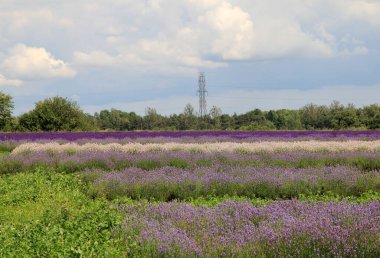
[0,92,380,132]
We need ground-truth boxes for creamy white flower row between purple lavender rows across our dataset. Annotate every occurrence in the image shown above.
[12,140,380,154]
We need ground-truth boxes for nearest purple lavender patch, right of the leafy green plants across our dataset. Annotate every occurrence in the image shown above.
[120,200,380,257]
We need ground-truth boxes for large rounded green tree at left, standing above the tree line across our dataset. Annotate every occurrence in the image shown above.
[19,96,96,132]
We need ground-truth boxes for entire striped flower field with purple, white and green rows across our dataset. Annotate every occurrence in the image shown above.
[0,131,380,257]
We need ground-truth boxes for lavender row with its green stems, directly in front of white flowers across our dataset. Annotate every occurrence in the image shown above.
[0,150,380,174]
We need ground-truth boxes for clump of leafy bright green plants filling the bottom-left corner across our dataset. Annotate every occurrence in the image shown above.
[0,169,125,257]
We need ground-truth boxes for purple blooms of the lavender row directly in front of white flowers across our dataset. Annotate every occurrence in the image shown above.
[5,150,380,168]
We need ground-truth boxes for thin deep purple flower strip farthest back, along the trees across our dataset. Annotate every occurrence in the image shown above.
[0,131,380,141]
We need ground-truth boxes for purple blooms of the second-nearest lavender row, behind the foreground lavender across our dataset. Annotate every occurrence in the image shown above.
[96,166,370,187]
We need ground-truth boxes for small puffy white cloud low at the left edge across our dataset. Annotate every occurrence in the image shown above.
[1,44,76,80]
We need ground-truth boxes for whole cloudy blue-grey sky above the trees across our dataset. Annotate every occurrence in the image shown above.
[0,0,380,115]
